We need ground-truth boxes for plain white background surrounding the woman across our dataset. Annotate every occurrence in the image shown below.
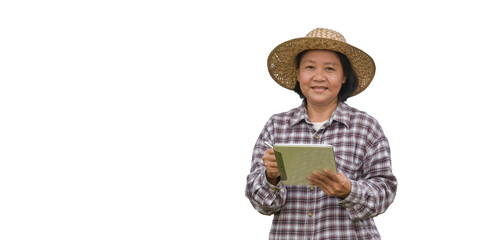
[0,0,480,239]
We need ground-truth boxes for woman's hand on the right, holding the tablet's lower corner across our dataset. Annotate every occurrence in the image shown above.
[308,169,352,198]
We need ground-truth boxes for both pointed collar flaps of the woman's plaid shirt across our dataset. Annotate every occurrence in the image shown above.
[290,100,350,127]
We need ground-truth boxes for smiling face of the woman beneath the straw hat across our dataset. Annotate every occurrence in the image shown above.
[297,50,347,106]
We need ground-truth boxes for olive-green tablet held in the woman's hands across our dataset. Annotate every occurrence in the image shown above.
[273,144,337,185]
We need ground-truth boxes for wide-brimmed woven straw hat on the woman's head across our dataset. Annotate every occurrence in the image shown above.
[267,28,375,96]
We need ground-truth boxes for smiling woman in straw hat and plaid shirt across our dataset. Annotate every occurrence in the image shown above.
[246,28,397,240]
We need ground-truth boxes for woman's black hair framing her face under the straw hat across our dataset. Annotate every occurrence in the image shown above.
[293,50,358,102]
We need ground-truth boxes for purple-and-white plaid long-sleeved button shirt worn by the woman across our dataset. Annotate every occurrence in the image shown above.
[246,103,397,240]
